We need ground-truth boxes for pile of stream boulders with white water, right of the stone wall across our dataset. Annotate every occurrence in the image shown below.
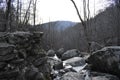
[49,47,120,80]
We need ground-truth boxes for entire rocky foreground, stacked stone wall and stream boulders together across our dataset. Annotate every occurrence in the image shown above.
[0,32,120,80]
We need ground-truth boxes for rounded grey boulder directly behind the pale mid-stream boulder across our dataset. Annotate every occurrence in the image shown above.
[62,49,80,60]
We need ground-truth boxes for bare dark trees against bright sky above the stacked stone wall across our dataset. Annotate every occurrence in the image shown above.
[0,0,37,32]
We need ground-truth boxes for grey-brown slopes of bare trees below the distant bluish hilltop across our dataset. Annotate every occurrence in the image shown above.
[42,6,120,50]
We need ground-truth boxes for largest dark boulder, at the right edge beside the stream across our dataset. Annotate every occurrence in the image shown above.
[87,46,120,77]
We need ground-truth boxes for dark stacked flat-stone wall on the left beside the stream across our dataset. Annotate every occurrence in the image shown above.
[0,32,51,80]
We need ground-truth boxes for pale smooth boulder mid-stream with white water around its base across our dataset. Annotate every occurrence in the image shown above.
[63,57,86,67]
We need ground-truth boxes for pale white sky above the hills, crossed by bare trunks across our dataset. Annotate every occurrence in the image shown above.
[31,0,114,24]
